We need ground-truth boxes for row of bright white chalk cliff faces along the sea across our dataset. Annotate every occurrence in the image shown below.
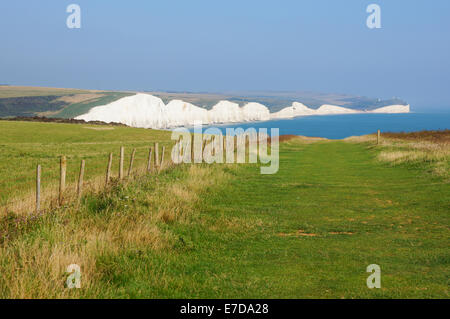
[76,93,409,129]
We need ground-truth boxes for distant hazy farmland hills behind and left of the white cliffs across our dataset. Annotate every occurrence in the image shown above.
[0,85,407,118]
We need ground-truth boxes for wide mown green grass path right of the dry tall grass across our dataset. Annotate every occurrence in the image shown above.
[96,142,450,298]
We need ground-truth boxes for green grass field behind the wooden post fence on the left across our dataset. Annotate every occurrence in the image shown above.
[0,121,170,207]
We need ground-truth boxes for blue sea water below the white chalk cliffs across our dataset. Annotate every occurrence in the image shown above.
[200,113,450,139]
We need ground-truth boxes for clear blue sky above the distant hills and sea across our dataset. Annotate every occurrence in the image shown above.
[0,0,450,110]
